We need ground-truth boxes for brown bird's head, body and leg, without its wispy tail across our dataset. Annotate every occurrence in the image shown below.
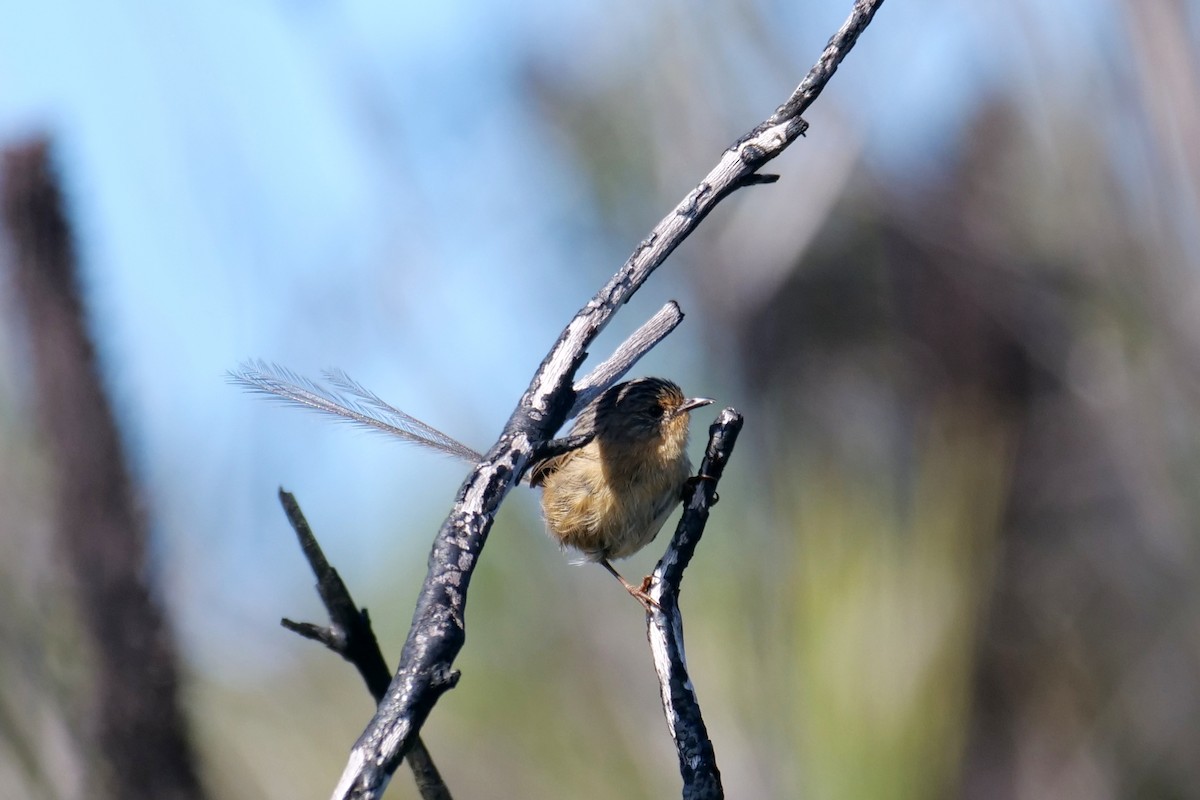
[529,378,713,604]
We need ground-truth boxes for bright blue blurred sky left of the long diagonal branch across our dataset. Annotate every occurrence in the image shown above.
[0,1,696,676]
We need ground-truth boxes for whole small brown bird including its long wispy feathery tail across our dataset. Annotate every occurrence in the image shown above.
[230,362,713,606]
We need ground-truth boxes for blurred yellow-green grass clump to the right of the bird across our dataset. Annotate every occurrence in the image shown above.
[719,409,1009,800]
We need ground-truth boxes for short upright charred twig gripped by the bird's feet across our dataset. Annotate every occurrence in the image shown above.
[646,408,742,800]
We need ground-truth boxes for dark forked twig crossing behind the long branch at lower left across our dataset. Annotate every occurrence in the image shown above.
[280,489,451,800]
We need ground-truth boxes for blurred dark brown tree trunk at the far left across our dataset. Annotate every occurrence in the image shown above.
[2,142,204,800]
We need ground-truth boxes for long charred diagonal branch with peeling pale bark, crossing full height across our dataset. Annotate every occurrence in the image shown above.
[334,0,882,799]
